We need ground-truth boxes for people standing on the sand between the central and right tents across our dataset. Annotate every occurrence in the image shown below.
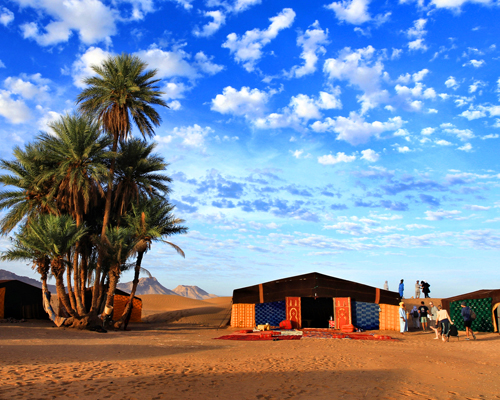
[399,301,476,342]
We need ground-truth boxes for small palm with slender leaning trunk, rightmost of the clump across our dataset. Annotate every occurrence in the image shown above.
[115,198,188,328]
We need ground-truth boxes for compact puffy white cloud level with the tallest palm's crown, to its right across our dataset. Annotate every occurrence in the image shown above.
[210,86,274,118]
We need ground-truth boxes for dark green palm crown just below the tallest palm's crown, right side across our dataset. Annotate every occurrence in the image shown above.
[114,139,172,216]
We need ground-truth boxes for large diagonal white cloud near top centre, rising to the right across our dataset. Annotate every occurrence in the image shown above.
[222,8,295,72]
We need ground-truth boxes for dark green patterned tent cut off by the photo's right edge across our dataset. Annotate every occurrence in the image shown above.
[441,289,500,332]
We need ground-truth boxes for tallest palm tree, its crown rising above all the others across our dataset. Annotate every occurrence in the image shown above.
[77,53,168,312]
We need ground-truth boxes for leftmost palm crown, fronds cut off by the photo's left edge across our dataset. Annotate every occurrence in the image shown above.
[0,143,59,235]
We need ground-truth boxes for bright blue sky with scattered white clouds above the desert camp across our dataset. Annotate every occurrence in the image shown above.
[0,0,500,297]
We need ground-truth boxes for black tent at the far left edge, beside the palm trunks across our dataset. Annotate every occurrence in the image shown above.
[0,280,49,319]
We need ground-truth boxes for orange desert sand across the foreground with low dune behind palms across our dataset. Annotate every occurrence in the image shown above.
[0,295,500,400]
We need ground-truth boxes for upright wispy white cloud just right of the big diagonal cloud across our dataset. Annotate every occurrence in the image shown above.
[287,21,328,78]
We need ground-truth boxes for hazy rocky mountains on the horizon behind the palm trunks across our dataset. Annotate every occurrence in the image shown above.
[0,269,218,300]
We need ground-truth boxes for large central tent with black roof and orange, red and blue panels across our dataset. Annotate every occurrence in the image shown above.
[231,272,399,329]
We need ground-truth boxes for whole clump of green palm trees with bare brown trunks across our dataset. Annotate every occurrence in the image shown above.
[0,54,187,328]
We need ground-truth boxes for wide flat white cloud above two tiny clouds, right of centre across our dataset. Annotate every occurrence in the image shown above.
[311,112,405,145]
